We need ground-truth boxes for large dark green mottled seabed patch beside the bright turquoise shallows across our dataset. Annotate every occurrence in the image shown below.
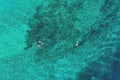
[26,1,83,49]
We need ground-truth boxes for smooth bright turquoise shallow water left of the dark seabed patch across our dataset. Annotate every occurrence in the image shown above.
[0,0,41,58]
